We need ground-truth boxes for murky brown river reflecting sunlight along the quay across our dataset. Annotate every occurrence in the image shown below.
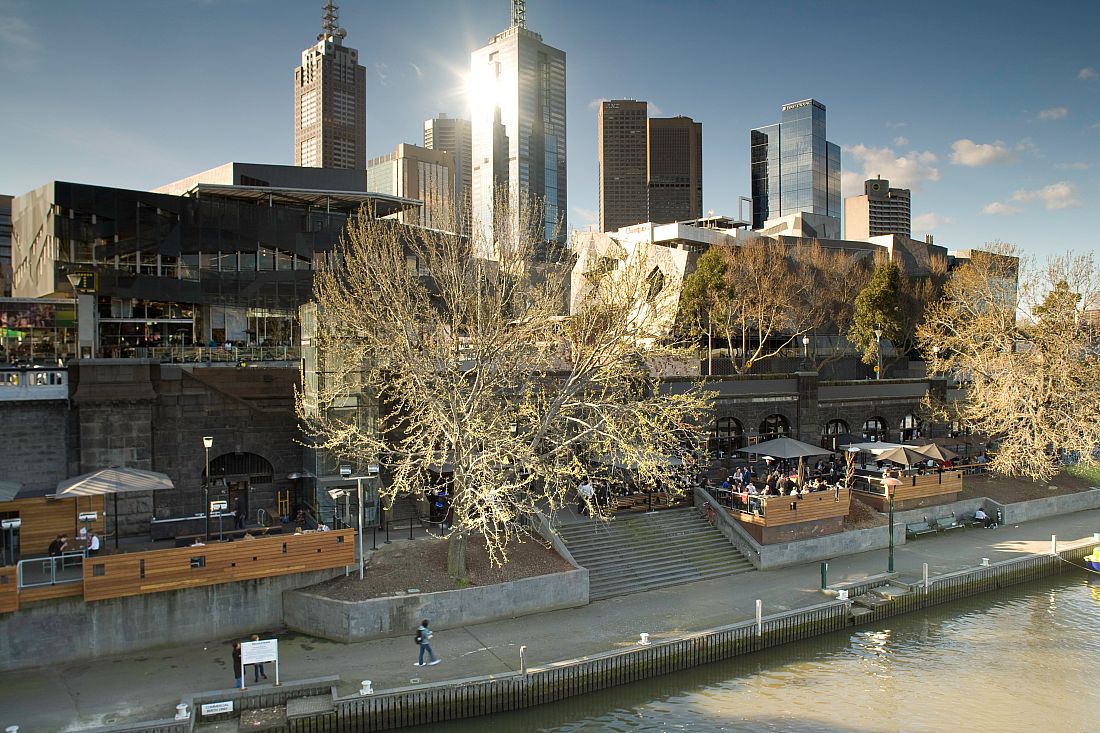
[420,571,1100,733]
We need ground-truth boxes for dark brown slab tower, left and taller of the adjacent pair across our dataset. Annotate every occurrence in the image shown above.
[596,99,649,231]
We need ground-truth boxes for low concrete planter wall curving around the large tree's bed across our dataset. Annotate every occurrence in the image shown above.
[283,568,589,642]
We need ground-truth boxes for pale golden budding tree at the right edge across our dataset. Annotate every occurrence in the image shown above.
[917,244,1100,480]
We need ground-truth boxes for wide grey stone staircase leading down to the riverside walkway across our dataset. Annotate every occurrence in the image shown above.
[558,507,752,601]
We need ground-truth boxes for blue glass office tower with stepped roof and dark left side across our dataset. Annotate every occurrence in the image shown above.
[749,99,840,239]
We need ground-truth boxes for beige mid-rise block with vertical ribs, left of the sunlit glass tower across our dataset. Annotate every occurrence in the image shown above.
[366,143,454,230]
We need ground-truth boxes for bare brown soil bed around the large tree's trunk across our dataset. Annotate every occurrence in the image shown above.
[309,530,576,601]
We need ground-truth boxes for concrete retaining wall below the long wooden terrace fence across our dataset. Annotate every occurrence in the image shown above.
[0,561,343,670]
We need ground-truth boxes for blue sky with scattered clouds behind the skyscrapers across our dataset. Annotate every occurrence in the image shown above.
[0,0,1100,256]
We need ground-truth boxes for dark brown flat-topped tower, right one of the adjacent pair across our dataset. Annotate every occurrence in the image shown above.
[648,117,703,223]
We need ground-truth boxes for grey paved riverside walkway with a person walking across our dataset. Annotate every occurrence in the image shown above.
[0,510,1100,733]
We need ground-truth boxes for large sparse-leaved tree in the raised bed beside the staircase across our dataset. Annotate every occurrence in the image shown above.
[298,196,708,578]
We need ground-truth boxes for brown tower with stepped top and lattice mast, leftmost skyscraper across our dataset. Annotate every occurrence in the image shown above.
[294,0,366,171]
